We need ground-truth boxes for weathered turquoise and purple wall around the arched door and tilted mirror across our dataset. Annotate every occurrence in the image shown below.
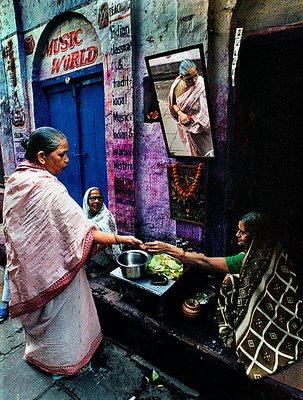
[0,0,303,255]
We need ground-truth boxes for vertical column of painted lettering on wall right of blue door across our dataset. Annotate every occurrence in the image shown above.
[106,0,135,234]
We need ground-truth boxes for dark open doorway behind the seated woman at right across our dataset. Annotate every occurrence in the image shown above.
[231,28,303,286]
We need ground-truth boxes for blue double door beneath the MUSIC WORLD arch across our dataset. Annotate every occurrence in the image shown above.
[39,67,107,205]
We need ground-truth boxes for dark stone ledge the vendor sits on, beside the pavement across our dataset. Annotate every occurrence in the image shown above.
[91,281,303,400]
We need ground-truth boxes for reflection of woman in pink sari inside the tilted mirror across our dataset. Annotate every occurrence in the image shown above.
[168,59,214,157]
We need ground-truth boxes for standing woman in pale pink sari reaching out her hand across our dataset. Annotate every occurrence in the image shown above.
[4,127,142,377]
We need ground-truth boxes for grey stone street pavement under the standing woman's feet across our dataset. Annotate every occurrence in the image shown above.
[0,267,204,400]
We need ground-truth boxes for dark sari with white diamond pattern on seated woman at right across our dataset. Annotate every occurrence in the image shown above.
[217,227,303,379]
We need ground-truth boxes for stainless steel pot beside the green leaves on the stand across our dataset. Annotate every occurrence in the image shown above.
[117,250,151,279]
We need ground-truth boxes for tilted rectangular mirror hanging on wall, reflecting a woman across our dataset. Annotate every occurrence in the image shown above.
[145,44,215,158]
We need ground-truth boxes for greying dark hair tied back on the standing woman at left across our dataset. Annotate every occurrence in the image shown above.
[21,126,66,162]
